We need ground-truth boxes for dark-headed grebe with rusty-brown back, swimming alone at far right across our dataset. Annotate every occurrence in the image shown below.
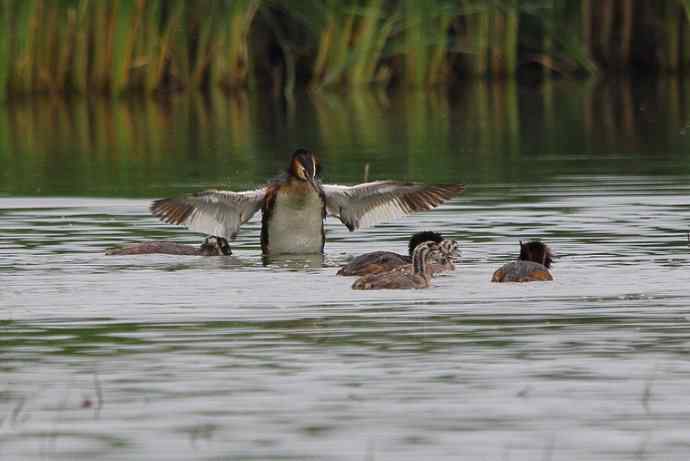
[491,240,553,282]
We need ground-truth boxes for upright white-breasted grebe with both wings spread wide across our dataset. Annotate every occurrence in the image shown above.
[151,149,464,255]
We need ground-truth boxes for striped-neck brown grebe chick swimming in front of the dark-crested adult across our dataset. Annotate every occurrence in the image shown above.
[352,242,446,290]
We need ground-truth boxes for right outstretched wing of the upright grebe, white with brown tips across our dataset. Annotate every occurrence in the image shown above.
[322,181,465,231]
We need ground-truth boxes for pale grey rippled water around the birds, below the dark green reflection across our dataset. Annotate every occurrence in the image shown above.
[0,176,690,460]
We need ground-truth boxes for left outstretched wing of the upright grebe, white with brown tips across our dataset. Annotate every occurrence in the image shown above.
[151,188,266,239]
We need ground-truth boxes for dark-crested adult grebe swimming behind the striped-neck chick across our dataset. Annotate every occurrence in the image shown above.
[336,231,455,277]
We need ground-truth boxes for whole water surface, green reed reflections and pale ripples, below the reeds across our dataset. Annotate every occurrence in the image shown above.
[0,82,690,460]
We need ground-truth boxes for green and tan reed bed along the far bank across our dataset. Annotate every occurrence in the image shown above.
[0,0,690,96]
